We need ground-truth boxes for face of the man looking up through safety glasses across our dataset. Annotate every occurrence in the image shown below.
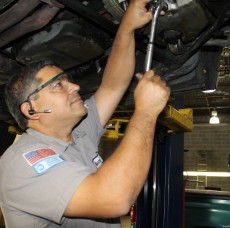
[32,66,87,126]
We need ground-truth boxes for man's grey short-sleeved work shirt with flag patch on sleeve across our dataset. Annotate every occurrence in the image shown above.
[0,97,120,228]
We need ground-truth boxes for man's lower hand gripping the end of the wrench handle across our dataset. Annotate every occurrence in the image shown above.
[134,70,170,117]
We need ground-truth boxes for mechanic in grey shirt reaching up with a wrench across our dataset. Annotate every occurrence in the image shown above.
[0,0,170,228]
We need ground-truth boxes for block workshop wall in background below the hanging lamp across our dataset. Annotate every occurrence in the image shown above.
[184,124,230,191]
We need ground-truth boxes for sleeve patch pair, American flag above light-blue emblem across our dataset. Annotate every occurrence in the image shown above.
[23,148,64,174]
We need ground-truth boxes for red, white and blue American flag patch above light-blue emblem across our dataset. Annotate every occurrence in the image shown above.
[23,148,58,166]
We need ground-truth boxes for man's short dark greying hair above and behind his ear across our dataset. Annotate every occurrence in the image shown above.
[5,60,57,130]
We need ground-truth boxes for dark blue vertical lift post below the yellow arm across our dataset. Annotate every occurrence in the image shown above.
[155,133,184,228]
